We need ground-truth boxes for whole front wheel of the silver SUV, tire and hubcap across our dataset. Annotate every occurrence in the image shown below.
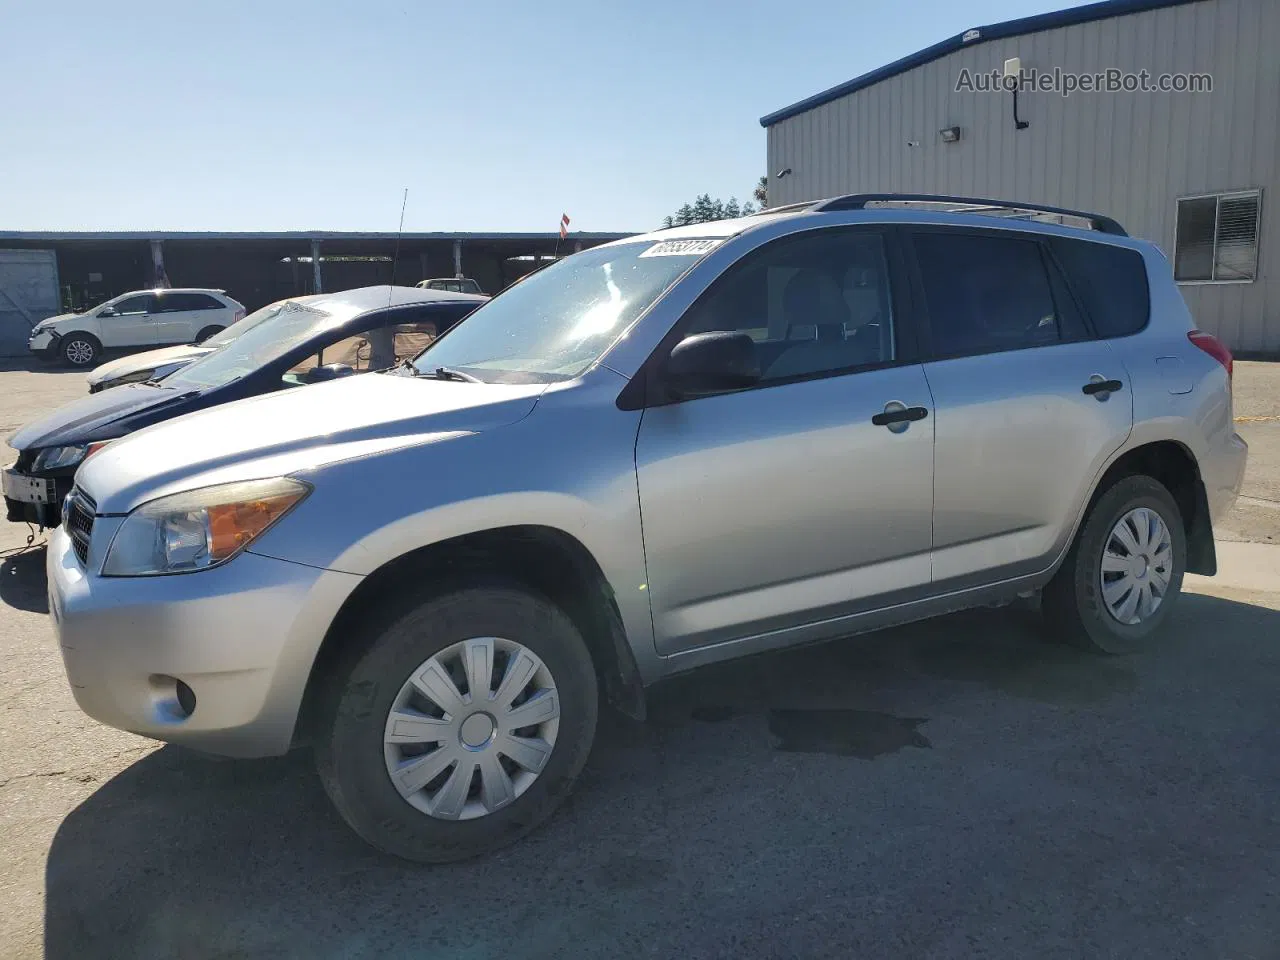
[316,588,598,863]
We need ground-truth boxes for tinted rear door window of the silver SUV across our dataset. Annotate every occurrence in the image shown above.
[913,233,1062,356]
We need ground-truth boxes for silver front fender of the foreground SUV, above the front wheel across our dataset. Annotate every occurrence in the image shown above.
[251,383,658,676]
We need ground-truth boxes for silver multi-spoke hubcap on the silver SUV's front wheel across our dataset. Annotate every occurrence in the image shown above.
[383,636,559,820]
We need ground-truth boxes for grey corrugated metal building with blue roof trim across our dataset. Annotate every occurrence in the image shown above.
[760,0,1280,353]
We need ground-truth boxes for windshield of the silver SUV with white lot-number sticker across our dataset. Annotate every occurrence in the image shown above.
[413,242,707,383]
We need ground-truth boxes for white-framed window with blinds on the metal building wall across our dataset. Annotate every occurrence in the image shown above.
[1174,191,1262,283]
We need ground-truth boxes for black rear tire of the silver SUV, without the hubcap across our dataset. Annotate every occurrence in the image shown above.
[1041,476,1187,654]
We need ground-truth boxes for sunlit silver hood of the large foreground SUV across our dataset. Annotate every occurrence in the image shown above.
[76,374,547,513]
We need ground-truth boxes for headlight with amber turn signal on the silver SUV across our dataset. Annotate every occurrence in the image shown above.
[102,476,311,577]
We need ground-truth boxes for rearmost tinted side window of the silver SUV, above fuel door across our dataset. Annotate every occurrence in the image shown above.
[1053,237,1151,337]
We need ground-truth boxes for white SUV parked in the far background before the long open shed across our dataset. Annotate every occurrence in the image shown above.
[27,288,244,366]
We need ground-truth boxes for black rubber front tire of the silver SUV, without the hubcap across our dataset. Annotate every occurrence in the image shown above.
[315,586,598,863]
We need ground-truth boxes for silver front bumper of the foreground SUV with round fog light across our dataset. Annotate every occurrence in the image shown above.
[47,527,361,756]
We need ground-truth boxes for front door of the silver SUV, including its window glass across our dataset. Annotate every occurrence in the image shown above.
[636,228,933,654]
